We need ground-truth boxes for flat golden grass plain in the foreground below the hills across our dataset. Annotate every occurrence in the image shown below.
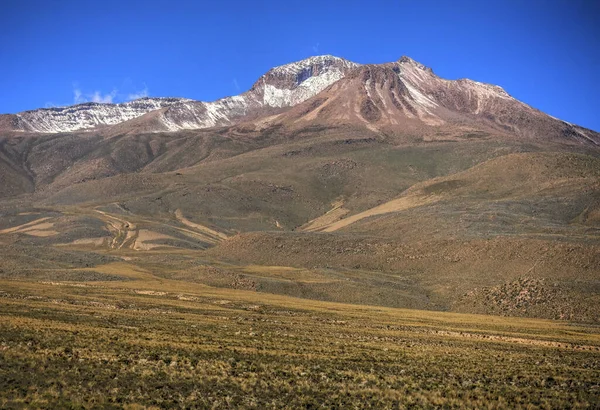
[0,262,600,409]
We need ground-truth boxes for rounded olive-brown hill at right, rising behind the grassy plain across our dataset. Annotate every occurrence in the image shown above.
[208,153,600,321]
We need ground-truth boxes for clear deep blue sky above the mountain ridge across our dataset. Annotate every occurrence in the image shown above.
[0,0,600,131]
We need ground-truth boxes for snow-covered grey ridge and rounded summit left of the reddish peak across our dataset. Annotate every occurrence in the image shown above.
[0,56,358,133]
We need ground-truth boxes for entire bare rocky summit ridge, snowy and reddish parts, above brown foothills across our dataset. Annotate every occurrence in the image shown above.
[0,55,600,145]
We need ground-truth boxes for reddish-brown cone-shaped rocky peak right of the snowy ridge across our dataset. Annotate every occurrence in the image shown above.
[274,57,600,146]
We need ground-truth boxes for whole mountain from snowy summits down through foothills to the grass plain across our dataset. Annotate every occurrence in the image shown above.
[0,56,600,322]
